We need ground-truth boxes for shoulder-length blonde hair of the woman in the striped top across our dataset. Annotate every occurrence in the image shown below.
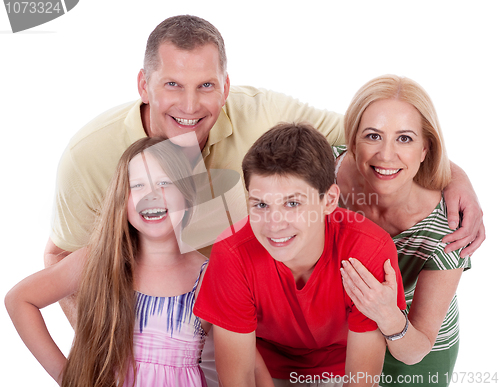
[344,75,451,191]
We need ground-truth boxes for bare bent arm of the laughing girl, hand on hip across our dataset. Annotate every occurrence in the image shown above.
[5,249,85,384]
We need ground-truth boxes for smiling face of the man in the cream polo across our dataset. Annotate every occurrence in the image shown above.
[138,43,229,149]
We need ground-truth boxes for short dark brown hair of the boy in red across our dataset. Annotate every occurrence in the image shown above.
[242,123,335,197]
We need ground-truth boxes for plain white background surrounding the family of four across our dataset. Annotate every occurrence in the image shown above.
[0,0,500,386]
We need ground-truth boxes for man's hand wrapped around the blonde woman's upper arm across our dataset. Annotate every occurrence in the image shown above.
[443,163,486,258]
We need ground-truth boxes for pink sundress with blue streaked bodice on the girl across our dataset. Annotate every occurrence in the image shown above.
[124,261,208,387]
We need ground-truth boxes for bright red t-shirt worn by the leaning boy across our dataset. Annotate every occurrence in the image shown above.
[194,208,406,379]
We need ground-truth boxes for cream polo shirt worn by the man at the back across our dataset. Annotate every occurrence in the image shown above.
[50,86,345,251]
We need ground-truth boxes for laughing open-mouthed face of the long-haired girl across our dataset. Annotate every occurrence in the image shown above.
[127,151,186,240]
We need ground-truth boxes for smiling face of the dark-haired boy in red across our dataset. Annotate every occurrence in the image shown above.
[248,174,339,272]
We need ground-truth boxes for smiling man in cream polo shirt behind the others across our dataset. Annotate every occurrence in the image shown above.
[45,15,484,334]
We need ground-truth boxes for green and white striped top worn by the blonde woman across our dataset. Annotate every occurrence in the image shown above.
[333,146,471,351]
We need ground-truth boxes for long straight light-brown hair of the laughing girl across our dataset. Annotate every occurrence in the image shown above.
[62,137,196,387]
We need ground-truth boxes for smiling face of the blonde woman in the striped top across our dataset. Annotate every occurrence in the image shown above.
[354,99,427,194]
